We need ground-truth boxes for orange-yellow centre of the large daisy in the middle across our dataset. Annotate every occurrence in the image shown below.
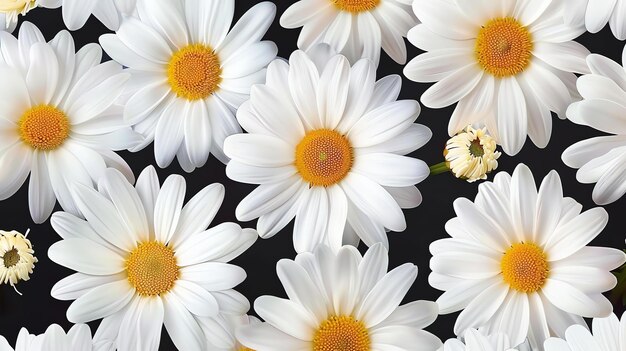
[296,129,352,186]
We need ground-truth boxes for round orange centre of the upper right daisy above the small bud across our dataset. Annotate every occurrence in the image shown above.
[475,17,533,78]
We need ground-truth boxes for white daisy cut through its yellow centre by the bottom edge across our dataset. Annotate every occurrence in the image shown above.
[237,244,441,351]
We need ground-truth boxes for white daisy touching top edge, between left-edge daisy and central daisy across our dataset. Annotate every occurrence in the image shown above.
[100,0,278,172]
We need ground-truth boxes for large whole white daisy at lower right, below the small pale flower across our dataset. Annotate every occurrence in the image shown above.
[429,164,626,349]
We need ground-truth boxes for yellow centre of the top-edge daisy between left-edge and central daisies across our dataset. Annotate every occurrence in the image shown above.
[167,44,222,101]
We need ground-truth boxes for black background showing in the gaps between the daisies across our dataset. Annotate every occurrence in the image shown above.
[0,0,626,350]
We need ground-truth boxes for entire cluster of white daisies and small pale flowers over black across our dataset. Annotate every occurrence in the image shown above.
[0,0,626,351]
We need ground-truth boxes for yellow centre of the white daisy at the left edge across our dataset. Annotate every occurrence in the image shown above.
[17,105,70,151]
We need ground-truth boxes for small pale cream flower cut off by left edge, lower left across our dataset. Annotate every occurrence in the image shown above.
[0,230,38,294]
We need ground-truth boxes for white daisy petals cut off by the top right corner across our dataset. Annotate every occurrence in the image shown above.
[564,0,626,40]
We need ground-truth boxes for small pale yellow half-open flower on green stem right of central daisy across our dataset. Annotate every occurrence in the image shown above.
[443,126,501,183]
